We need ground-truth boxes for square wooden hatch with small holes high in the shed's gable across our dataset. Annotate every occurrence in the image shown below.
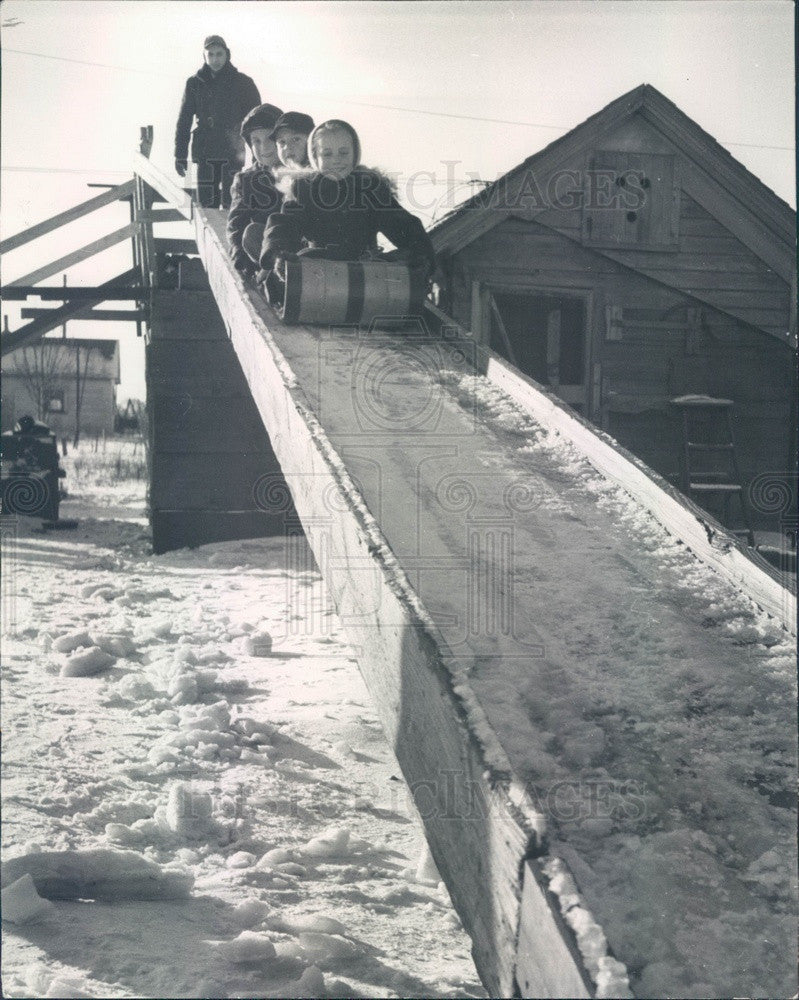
[582,152,680,250]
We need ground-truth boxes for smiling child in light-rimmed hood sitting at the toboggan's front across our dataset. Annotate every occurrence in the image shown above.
[260,119,435,290]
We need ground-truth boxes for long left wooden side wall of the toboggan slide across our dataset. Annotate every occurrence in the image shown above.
[194,206,608,997]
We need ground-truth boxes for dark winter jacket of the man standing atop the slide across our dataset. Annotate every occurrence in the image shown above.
[175,62,261,164]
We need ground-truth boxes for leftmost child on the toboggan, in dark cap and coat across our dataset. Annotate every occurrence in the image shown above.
[227,104,285,278]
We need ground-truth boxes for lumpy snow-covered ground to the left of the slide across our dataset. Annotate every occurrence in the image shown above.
[2,443,484,997]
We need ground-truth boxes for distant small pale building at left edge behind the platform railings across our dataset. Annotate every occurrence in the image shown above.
[0,337,120,437]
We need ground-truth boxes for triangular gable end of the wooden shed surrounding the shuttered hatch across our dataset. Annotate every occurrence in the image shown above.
[431,86,795,342]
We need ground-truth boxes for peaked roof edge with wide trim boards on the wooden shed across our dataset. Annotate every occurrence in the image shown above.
[430,83,796,282]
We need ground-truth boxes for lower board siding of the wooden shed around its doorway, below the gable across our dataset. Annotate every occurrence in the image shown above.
[452,199,792,530]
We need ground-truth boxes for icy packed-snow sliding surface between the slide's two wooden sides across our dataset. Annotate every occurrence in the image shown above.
[248,314,797,997]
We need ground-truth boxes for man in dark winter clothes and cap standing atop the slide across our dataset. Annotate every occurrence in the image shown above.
[175,35,261,208]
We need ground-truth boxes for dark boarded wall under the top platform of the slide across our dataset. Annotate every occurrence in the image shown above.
[146,290,285,552]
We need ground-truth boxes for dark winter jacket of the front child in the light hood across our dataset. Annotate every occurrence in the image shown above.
[261,167,435,270]
